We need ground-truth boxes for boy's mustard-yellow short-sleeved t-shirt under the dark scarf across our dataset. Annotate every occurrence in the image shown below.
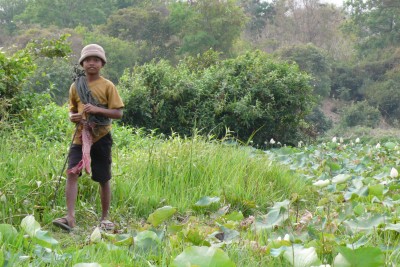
[69,77,124,144]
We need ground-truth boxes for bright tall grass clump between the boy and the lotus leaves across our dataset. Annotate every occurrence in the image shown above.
[114,131,304,216]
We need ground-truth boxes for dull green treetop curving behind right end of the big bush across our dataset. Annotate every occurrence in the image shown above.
[277,44,331,97]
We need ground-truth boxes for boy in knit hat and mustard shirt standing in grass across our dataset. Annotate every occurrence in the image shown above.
[53,44,124,230]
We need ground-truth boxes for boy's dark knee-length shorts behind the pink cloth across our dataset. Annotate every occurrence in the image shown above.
[68,133,113,183]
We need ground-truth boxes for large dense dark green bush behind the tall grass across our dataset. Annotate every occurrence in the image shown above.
[119,51,313,145]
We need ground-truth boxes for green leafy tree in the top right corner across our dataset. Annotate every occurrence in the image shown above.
[344,0,400,56]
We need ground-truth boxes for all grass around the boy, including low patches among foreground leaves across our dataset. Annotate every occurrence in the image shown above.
[0,122,308,266]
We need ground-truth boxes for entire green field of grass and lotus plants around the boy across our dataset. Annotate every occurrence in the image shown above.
[0,105,400,267]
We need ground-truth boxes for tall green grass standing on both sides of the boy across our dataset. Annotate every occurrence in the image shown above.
[0,123,305,226]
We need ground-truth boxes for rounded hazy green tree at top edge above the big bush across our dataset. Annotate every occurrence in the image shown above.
[169,0,246,55]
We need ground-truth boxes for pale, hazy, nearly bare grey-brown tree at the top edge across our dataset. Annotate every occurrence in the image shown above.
[259,0,352,58]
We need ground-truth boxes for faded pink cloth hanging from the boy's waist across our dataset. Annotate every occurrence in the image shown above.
[68,123,93,174]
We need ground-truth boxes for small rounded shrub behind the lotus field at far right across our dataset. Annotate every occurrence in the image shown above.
[342,101,381,128]
